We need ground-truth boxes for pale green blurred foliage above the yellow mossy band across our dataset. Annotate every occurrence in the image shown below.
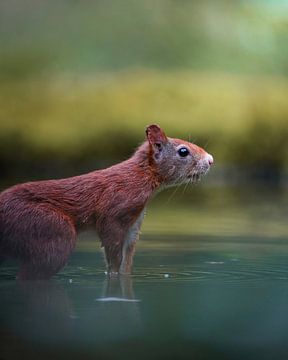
[0,0,288,75]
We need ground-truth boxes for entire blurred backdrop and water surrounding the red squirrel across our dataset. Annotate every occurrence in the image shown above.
[0,0,288,360]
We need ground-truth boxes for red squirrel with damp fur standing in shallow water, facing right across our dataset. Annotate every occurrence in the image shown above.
[0,125,213,280]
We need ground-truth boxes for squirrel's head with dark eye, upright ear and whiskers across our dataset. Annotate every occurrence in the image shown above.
[146,124,213,186]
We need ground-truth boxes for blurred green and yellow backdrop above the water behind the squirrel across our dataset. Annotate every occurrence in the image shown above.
[0,0,288,187]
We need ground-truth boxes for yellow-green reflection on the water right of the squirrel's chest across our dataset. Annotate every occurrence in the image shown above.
[143,185,288,239]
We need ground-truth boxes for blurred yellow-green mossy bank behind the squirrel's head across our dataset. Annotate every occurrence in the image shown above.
[0,71,288,183]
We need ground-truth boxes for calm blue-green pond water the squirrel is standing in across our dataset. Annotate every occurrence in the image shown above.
[0,188,288,360]
